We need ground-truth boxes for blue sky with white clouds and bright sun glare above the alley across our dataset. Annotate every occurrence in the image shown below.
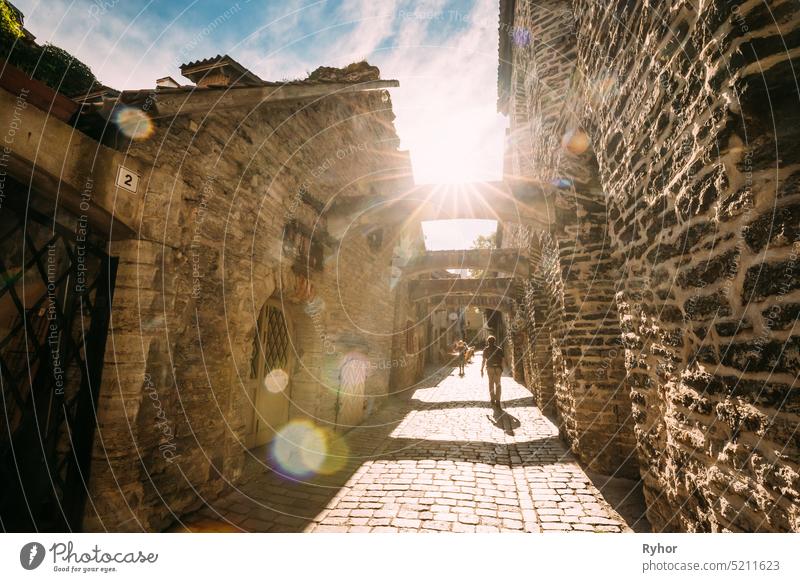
[14,0,506,248]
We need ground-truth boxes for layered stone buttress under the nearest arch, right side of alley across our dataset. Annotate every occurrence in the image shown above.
[549,190,638,476]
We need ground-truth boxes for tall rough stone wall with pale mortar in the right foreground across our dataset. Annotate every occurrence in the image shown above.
[500,0,800,531]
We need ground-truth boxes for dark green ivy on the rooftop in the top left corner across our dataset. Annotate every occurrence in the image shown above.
[0,0,97,96]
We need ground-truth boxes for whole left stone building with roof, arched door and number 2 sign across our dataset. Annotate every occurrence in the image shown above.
[4,50,438,530]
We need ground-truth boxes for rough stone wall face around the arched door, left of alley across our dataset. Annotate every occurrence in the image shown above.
[85,91,410,531]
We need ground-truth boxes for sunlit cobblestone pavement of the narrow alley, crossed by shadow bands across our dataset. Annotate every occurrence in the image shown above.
[174,359,630,532]
